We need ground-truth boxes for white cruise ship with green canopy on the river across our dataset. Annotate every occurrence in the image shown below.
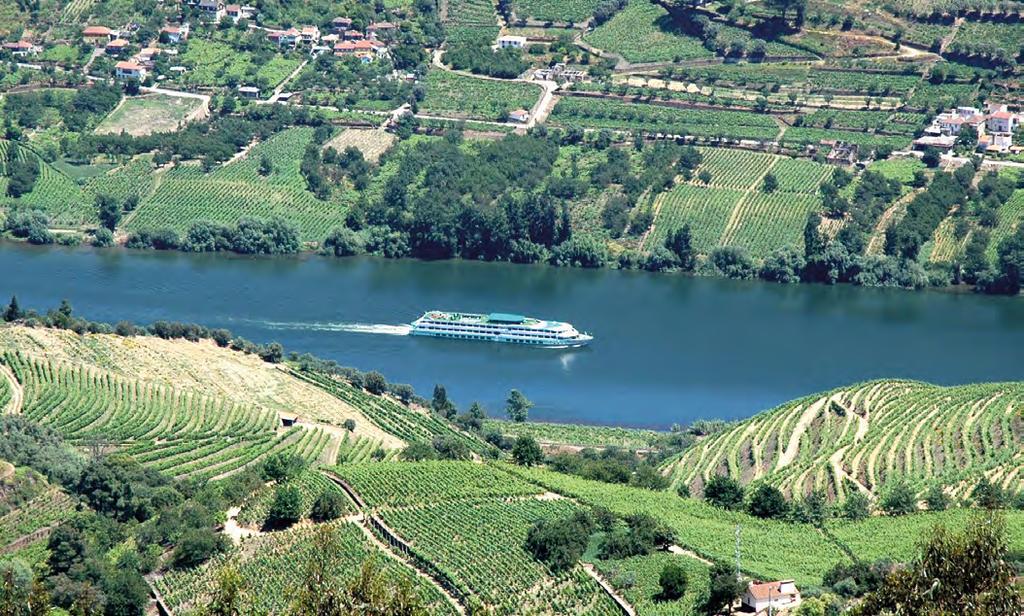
[411,310,594,348]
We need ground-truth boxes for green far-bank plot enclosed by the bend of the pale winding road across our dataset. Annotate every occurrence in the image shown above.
[420,71,541,121]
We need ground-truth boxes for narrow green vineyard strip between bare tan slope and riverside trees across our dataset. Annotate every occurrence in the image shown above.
[297,372,483,451]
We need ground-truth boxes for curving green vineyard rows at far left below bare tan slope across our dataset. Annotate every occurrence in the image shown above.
[0,352,331,479]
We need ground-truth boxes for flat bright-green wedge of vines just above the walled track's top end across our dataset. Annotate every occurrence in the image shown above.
[334,461,542,507]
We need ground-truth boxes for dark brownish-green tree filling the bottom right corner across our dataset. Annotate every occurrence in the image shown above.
[851,514,1024,616]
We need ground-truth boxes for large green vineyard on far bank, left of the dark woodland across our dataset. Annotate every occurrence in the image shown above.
[127,127,345,241]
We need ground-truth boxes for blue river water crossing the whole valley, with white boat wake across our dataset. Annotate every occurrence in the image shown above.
[0,243,1024,428]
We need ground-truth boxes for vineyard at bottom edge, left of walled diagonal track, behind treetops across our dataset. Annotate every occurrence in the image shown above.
[155,523,456,616]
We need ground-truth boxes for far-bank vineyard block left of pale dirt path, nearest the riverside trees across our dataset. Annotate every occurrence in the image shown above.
[645,183,743,253]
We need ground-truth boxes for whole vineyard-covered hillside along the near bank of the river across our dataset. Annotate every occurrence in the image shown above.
[0,301,1024,614]
